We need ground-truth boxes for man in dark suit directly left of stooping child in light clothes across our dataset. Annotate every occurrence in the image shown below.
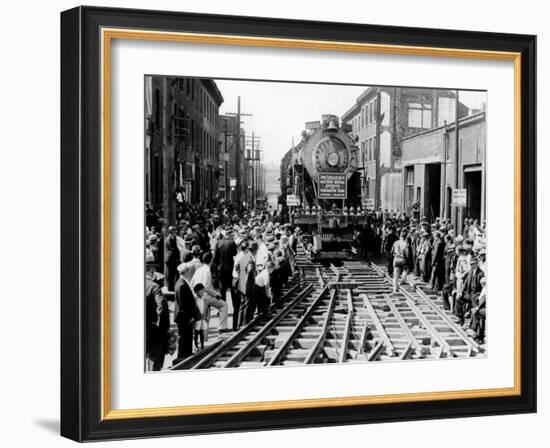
[174,272,197,358]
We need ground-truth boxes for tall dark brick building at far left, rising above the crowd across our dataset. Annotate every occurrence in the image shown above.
[145,76,223,222]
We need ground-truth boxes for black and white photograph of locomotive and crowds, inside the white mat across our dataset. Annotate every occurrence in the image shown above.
[144,75,488,372]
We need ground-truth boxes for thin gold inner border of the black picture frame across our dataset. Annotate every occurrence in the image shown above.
[100,27,522,421]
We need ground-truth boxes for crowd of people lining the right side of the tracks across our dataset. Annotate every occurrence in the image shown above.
[379,212,487,343]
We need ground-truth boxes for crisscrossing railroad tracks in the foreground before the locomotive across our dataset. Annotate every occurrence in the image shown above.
[175,252,483,369]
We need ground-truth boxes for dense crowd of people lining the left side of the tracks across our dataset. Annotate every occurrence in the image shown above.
[146,203,301,370]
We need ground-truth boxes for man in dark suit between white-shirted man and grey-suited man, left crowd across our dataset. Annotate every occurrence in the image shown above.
[213,228,239,330]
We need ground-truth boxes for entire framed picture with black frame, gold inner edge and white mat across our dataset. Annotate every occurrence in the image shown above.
[61,7,537,441]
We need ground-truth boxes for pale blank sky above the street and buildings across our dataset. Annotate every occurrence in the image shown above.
[216,80,486,164]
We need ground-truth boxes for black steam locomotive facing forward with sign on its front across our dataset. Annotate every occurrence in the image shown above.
[279,115,364,259]
